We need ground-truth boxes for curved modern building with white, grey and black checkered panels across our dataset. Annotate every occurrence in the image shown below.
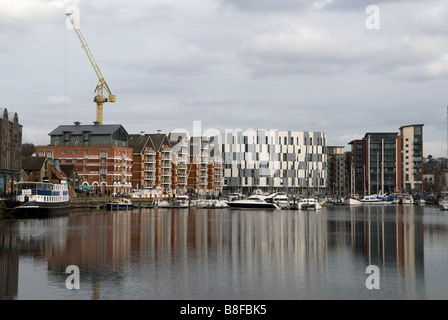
[210,129,327,195]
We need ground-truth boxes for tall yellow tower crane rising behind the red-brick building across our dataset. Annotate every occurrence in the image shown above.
[65,12,116,124]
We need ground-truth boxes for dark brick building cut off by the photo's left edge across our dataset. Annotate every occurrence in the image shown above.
[0,108,22,193]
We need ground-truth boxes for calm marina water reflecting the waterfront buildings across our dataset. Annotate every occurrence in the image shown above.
[0,206,448,300]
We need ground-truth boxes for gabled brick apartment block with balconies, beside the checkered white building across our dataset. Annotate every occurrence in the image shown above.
[129,131,223,196]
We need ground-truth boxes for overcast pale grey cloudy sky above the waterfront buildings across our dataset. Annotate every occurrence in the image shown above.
[0,0,448,157]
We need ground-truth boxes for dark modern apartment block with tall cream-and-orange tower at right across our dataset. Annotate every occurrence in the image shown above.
[349,124,423,195]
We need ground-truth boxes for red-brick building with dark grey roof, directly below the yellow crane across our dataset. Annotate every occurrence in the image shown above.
[36,121,132,194]
